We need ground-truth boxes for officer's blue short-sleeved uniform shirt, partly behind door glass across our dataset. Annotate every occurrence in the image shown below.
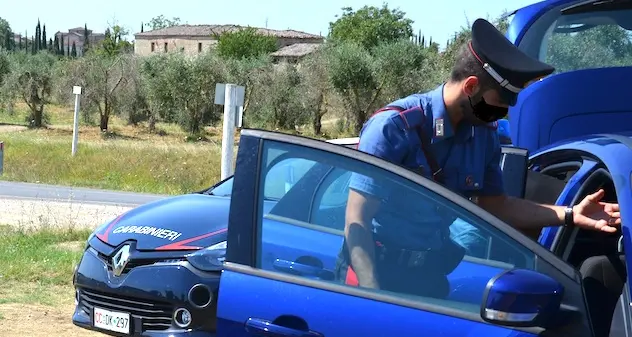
[350,85,504,249]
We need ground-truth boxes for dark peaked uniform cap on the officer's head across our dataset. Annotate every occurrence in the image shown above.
[469,19,555,106]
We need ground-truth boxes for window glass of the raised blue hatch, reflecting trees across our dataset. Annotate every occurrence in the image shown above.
[519,4,632,73]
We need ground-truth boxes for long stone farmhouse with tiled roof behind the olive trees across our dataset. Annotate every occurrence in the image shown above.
[134,25,324,56]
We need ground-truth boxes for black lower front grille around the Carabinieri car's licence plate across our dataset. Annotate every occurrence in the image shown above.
[79,289,173,331]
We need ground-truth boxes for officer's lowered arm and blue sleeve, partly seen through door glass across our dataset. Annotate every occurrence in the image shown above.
[345,116,408,288]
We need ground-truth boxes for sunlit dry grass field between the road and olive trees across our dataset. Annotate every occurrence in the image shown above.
[0,104,345,194]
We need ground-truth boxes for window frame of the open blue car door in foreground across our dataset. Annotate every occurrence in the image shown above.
[220,129,587,334]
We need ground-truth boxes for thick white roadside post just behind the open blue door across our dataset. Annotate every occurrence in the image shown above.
[215,83,245,180]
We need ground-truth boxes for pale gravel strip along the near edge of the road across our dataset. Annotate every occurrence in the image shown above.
[0,198,130,229]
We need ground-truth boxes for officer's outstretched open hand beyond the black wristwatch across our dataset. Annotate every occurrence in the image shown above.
[573,189,621,233]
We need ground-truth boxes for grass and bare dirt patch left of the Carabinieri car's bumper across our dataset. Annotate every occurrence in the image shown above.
[0,226,98,337]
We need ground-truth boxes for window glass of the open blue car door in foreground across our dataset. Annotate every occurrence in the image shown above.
[256,141,535,314]
